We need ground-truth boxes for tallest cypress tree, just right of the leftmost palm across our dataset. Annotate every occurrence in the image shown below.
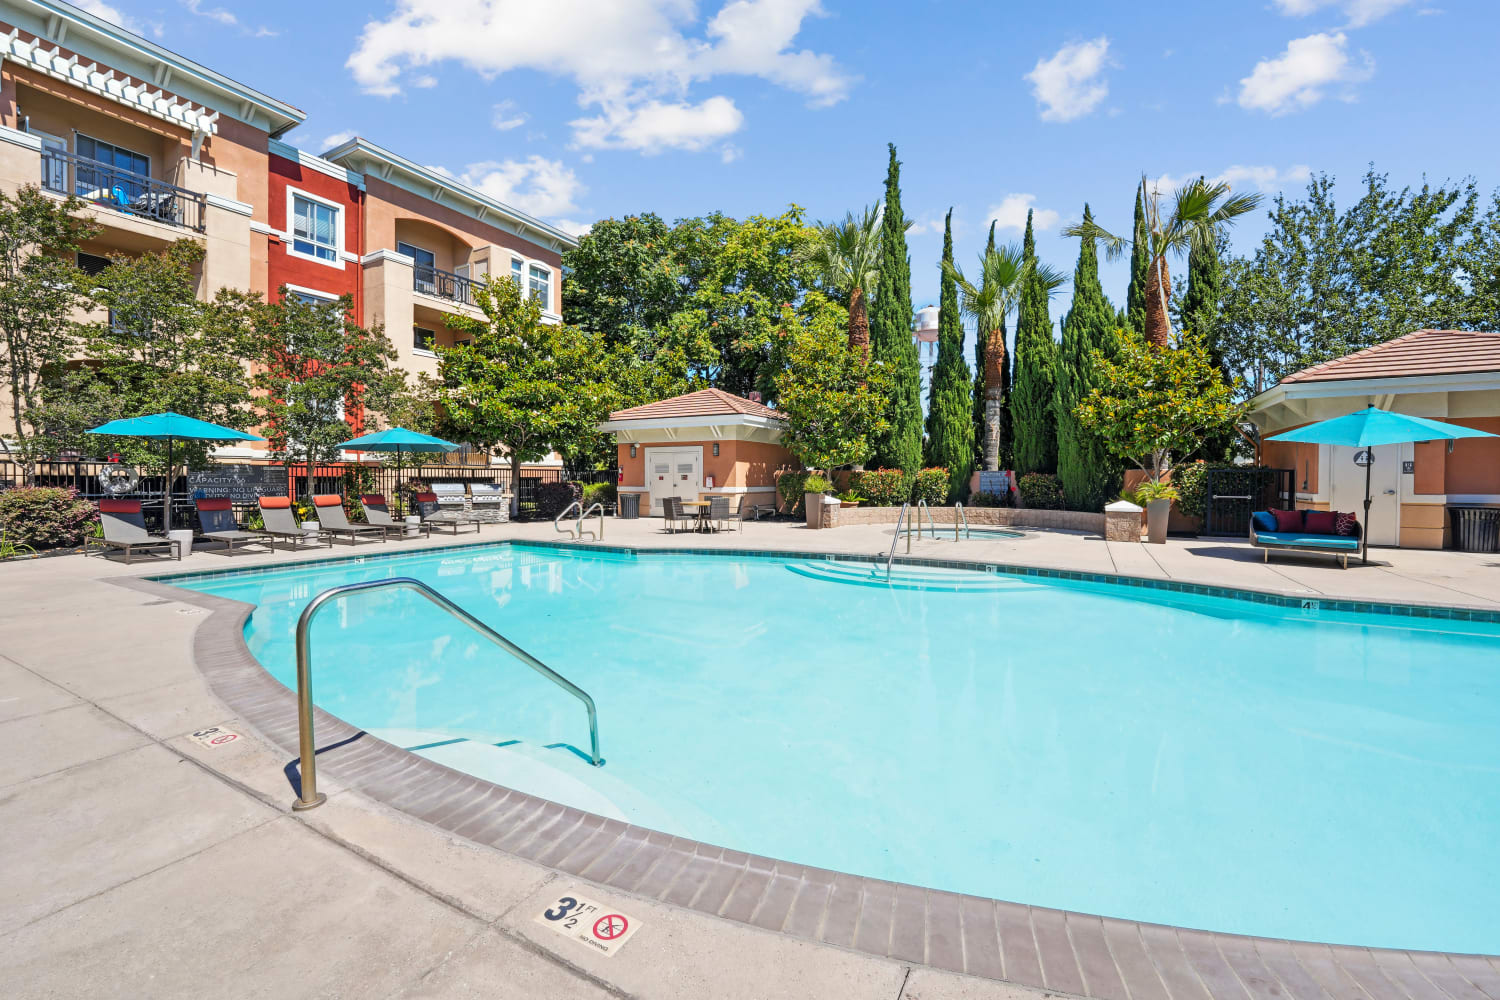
[870,142,923,472]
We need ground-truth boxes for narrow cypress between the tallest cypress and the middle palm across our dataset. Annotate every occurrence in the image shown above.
[927,208,974,498]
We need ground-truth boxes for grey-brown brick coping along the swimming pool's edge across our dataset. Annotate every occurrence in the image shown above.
[123,540,1500,1000]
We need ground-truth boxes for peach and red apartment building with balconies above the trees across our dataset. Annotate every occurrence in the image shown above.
[0,0,576,459]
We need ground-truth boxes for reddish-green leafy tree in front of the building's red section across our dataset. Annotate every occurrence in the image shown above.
[248,282,405,482]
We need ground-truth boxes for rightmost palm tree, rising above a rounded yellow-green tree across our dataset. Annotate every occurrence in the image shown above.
[1062,177,1260,348]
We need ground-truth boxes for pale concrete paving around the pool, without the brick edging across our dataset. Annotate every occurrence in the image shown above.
[0,520,1500,1000]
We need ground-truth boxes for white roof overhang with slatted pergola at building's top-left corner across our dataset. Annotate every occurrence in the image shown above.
[0,0,308,136]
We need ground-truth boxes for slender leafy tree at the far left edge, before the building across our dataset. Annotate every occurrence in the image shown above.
[0,186,98,481]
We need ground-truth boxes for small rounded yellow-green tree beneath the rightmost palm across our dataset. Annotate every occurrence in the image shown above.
[1077,328,1245,483]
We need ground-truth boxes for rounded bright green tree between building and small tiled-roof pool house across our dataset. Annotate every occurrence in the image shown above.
[432,280,617,513]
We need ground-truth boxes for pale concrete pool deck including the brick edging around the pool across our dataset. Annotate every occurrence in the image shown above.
[0,520,1500,1000]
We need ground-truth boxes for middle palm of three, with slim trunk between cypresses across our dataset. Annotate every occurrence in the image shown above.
[942,243,1068,472]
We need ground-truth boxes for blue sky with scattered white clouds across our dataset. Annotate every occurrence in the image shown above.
[83,0,1500,318]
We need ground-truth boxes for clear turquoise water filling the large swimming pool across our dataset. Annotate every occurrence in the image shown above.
[175,544,1500,952]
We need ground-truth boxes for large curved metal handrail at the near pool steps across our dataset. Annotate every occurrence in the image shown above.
[291,576,605,810]
